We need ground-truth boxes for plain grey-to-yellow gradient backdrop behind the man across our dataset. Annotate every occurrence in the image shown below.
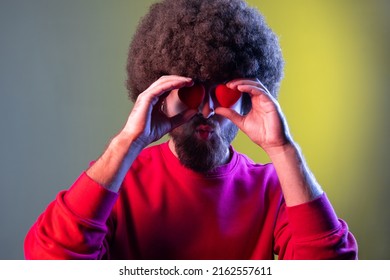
[0,0,390,259]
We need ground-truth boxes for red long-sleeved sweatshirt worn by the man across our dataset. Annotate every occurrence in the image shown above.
[25,143,357,259]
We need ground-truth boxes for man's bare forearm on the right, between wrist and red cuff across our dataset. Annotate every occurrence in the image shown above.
[267,141,323,206]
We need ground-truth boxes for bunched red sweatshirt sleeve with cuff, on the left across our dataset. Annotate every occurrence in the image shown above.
[24,172,118,260]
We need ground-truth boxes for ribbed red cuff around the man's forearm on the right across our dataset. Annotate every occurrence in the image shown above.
[287,193,340,238]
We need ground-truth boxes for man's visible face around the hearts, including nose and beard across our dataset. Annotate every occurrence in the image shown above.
[169,82,242,173]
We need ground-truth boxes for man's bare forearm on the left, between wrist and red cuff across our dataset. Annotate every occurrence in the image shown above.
[86,131,144,192]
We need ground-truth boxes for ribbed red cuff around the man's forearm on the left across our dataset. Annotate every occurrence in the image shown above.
[64,172,118,223]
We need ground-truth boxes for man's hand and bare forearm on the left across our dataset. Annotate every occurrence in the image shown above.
[86,76,196,192]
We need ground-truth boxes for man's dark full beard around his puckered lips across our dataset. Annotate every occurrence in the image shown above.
[170,115,238,173]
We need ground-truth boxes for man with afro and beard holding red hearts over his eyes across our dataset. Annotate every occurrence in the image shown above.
[25,0,357,259]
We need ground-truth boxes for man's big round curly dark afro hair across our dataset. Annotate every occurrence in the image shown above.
[127,0,284,104]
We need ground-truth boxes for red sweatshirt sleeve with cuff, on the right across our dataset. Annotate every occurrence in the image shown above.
[275,193,357,260]
